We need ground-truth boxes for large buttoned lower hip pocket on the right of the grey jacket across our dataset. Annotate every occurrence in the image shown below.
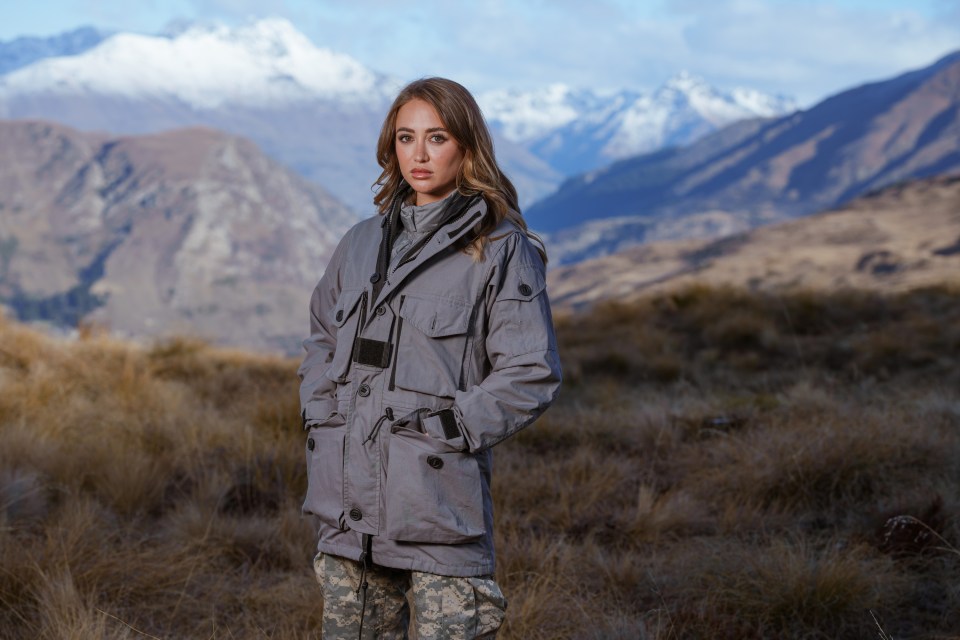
[386,428,486,544]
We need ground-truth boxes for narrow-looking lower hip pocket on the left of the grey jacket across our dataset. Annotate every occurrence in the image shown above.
[302,415,346,529]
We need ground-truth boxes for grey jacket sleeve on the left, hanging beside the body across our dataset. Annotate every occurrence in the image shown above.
[297,232,347,428]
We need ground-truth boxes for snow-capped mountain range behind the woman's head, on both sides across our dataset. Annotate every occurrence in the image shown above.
[0,18,792,213]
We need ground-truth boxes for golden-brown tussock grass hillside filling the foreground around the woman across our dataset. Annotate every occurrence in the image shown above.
[0,288,960,640]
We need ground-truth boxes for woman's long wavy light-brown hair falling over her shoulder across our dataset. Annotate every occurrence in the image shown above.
[373,78,547,263]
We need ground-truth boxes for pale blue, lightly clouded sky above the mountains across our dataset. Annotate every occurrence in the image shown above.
[0,0,960,106]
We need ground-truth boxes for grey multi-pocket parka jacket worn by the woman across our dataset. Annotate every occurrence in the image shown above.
[299,192,560,576]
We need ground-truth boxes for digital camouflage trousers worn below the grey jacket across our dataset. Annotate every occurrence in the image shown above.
[313,553,507,640]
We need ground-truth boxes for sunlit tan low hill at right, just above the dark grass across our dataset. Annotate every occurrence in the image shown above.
[548,174,960,307]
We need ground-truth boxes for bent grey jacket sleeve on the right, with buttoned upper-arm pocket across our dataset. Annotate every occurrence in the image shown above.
[454,233,561,452]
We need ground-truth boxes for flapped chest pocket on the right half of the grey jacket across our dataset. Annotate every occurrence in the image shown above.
[393,295,472,398]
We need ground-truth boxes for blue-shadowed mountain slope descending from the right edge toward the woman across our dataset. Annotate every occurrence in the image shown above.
[526,52,960,264]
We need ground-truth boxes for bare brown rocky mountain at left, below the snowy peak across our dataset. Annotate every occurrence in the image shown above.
[0,121,356,351]
